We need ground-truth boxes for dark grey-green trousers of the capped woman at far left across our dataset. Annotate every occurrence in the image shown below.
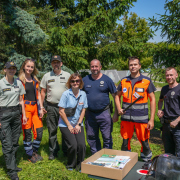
[0,110,22,175]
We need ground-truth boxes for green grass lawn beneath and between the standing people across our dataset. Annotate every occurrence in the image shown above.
[0,92,163,180]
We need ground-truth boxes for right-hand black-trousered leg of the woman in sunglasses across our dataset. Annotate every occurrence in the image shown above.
[75,126,86,170]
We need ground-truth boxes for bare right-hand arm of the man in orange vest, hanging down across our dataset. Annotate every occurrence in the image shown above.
[147,92,156,130]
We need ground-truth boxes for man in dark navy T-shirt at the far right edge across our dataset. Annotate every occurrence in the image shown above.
[157,67,180,157]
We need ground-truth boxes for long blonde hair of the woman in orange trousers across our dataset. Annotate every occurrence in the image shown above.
[19,59,40,84]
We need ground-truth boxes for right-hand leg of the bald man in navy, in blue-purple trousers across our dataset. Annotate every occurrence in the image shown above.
[96,109,113,149]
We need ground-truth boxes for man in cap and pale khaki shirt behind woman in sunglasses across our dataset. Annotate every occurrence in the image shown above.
[40,55,70,160]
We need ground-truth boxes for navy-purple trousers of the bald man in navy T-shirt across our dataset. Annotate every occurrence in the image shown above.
[85,109,113,154]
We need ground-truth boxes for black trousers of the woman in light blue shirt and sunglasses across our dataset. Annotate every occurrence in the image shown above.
[60,127,86,170]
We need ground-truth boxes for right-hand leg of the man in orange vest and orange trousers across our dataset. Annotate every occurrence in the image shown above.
[134,123,152,161]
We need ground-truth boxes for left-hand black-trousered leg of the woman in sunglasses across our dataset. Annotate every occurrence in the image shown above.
[60,127,77,169]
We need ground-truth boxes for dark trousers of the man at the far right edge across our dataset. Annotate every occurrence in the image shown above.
[162,123,180,157]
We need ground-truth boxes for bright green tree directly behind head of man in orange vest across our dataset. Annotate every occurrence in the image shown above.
[98,13,153,70]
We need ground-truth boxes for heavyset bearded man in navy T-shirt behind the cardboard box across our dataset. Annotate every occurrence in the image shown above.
[83,59,118,154]
